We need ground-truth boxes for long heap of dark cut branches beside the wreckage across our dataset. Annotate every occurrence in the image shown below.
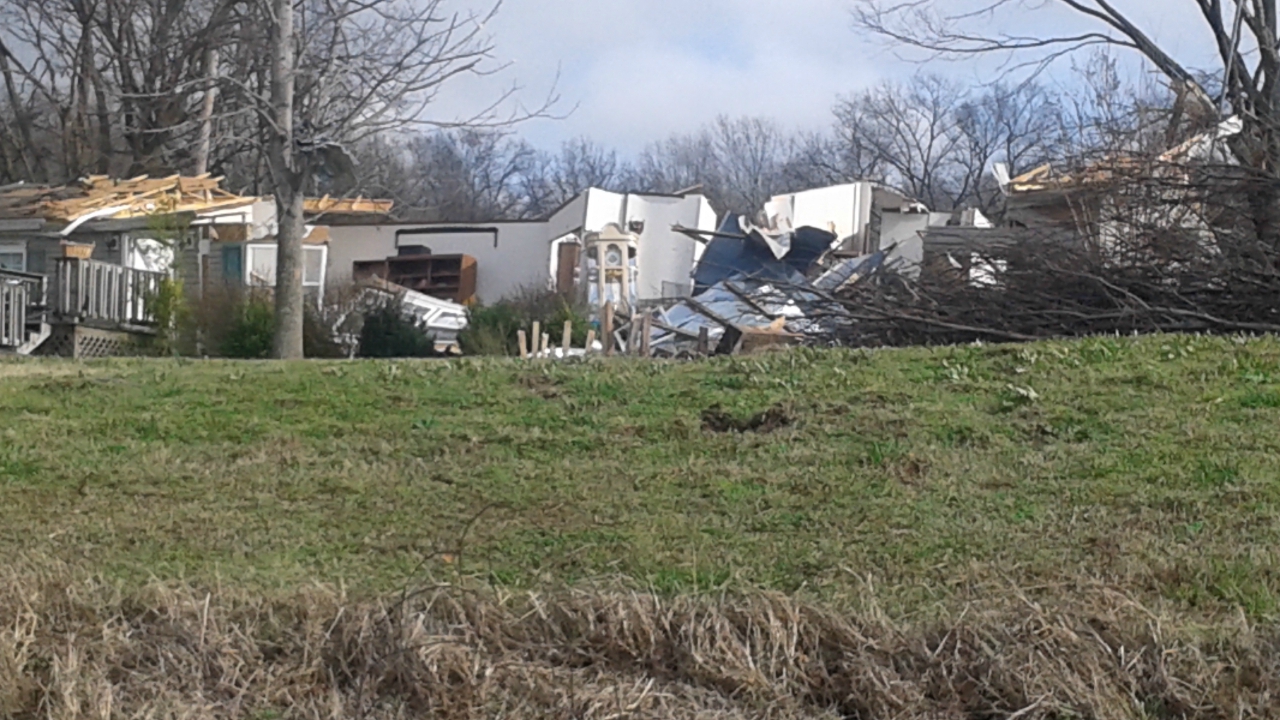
[835,181,1280,346]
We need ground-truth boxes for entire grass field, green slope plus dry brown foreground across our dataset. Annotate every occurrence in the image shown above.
[0,337,1280,720]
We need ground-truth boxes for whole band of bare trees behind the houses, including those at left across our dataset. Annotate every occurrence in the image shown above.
[0,0,1170,222]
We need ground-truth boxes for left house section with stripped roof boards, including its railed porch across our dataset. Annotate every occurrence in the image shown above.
[0,176,390,357]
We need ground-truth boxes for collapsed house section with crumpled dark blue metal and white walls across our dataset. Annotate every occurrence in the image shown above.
[640,182,989,356]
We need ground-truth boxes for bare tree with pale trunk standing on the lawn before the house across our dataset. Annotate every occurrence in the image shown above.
[226,0,545,357]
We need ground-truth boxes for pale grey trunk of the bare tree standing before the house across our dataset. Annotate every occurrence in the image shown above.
[269,0,306,360]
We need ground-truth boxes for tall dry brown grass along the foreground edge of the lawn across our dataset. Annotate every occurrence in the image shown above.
[0,563,1280,720]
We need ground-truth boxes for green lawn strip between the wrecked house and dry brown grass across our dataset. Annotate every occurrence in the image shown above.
[0,336,1280,618]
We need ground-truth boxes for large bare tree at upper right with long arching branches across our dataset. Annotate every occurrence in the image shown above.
[855,0,1280,247]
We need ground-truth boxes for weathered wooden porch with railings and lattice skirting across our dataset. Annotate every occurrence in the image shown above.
[0,258,168,357]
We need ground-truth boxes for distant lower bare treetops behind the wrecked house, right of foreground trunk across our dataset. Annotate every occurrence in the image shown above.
[307,54,1185,222]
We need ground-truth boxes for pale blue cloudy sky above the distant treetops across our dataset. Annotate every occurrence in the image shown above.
[436,0,1203,155]
